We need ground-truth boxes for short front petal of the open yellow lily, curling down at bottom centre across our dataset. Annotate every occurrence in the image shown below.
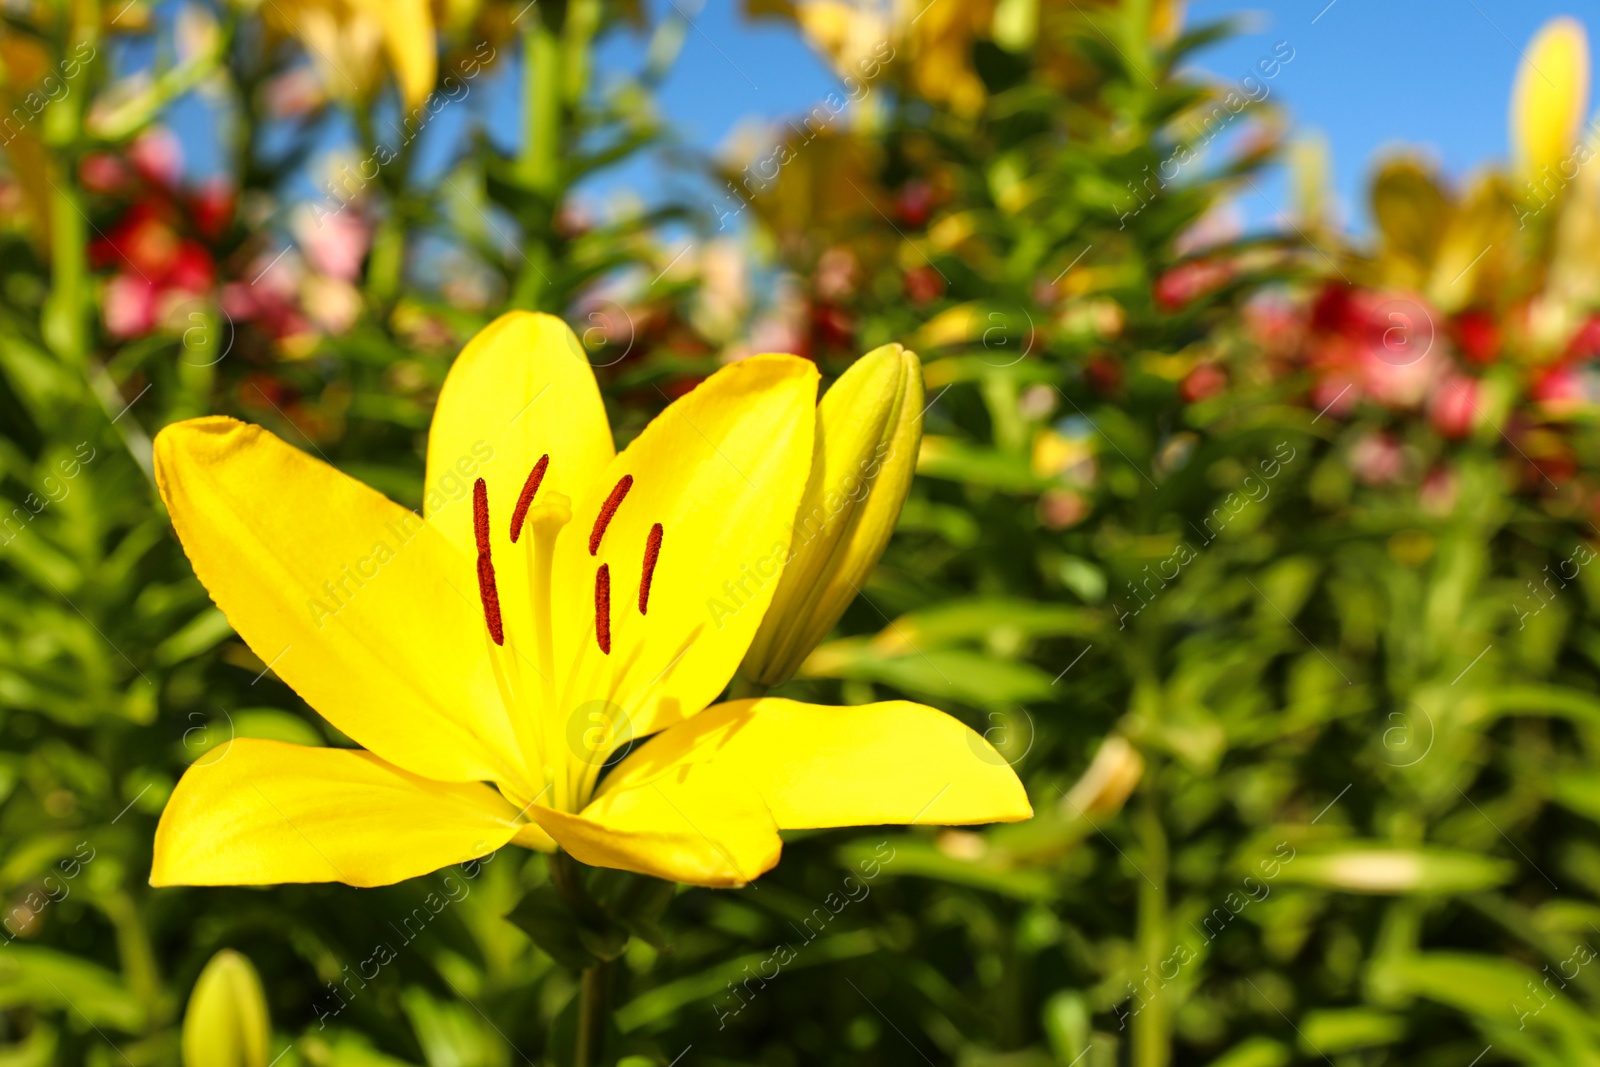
[528,774,782,888]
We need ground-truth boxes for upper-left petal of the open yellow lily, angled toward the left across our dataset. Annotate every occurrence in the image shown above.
[155,418,533,795]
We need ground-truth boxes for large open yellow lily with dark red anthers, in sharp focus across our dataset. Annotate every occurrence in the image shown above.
[150,312,1032,886]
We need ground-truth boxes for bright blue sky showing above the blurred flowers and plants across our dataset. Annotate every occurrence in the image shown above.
[585,0,1600,227]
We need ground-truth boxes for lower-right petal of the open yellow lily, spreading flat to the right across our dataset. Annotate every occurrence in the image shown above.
[600,697,1034,835]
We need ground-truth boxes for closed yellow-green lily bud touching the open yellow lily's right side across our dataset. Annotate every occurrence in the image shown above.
[739,344,923,686]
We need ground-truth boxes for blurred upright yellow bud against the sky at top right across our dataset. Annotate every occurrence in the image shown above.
[1510,16,1589,184]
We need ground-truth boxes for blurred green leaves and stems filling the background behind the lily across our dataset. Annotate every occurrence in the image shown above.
[0,0,1600,1067]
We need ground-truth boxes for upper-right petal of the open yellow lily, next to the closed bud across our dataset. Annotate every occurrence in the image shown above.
[555,355,818,757]
